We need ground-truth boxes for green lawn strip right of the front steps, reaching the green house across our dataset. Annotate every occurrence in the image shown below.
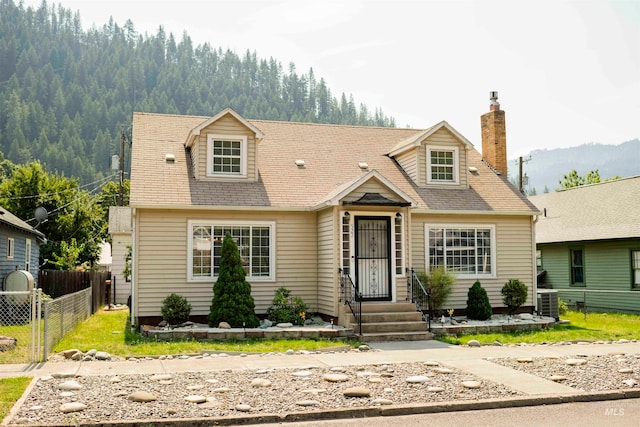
[438,311,640,344]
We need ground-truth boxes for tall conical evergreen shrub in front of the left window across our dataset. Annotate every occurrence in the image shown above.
[208,233,260,328]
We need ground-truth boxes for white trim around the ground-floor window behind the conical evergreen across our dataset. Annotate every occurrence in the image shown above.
[187,220,276,282]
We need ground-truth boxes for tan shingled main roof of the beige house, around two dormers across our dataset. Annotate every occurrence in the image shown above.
[130,110,536,215]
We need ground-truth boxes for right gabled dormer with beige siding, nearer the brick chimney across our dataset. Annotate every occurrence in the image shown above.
[387,121,473,188]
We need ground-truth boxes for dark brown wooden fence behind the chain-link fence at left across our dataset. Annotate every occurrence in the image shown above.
[38,270,111,313]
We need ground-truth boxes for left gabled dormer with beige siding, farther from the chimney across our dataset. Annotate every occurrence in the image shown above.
[184,108,263,181]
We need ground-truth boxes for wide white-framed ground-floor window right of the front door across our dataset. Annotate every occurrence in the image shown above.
[425,225,496,278]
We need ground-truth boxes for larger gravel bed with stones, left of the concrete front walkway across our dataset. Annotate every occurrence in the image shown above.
[12,362,520,425]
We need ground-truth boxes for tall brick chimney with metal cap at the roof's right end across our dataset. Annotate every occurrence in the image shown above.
[480,92,507,178]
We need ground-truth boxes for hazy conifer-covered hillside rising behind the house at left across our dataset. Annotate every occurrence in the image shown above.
[0,0,395,183]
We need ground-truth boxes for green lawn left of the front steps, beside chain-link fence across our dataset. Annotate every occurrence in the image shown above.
[53,310,355,357]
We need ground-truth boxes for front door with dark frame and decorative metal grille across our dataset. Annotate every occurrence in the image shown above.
[355,217,391,301]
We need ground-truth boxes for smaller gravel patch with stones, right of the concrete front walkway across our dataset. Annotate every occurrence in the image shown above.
[489,353,640,392]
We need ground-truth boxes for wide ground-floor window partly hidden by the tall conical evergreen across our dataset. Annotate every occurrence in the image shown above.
[188,221,275,281]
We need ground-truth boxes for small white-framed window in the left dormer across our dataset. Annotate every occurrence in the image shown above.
[207,135,247,177]
